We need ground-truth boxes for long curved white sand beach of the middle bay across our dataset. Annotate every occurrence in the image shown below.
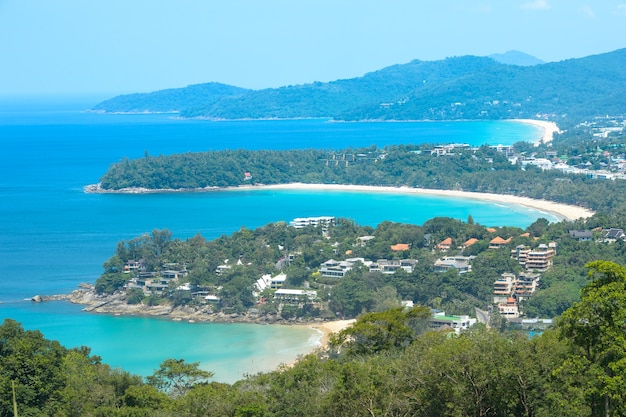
[232,183,594,220]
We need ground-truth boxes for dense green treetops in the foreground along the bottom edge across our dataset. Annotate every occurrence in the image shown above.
[6,261,626,417]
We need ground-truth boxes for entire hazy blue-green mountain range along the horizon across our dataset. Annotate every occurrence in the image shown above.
[96,49,626,122]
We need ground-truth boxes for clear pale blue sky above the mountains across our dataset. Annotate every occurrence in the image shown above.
[0,0,626,96]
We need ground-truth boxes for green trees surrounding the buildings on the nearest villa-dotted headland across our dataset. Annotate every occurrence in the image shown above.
[96,211,626,319]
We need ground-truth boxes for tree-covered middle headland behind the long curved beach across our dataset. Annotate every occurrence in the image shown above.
[95,143,626,213]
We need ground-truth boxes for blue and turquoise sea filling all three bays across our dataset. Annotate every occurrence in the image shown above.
[0,99,558,382]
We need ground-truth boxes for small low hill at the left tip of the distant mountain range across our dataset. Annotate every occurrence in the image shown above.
[92,83,250,113]
